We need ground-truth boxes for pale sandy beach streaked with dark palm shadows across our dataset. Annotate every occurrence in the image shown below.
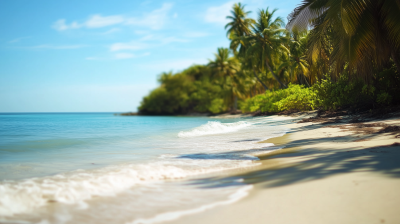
[168,114,400,224]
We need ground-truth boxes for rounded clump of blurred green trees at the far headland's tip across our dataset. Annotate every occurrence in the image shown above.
[139,65,227,115]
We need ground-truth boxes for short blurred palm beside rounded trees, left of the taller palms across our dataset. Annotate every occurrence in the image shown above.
[208,48,240,111]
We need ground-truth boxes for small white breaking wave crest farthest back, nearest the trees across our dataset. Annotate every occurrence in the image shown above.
[178,121,251,138]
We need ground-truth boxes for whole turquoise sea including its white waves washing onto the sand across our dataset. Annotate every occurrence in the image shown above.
[0,113,289,224]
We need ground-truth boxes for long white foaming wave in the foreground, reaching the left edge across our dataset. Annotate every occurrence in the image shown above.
[0,156,256,217]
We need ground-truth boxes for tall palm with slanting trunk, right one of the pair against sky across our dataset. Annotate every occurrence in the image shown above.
[246,8,289,88]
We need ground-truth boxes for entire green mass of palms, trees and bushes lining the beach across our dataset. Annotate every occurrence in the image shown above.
[139,0,400,114]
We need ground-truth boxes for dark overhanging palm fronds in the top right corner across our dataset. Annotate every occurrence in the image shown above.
[287,0,400,81]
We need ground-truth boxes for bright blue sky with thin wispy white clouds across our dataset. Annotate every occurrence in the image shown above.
[0,0,301,112]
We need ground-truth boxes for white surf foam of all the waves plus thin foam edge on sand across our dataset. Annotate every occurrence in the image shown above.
[0,116,284,223]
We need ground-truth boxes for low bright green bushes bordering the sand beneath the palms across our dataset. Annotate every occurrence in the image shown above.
[241,67,400,113]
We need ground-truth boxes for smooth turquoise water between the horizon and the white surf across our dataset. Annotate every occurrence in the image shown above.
[0,113,222,179]
